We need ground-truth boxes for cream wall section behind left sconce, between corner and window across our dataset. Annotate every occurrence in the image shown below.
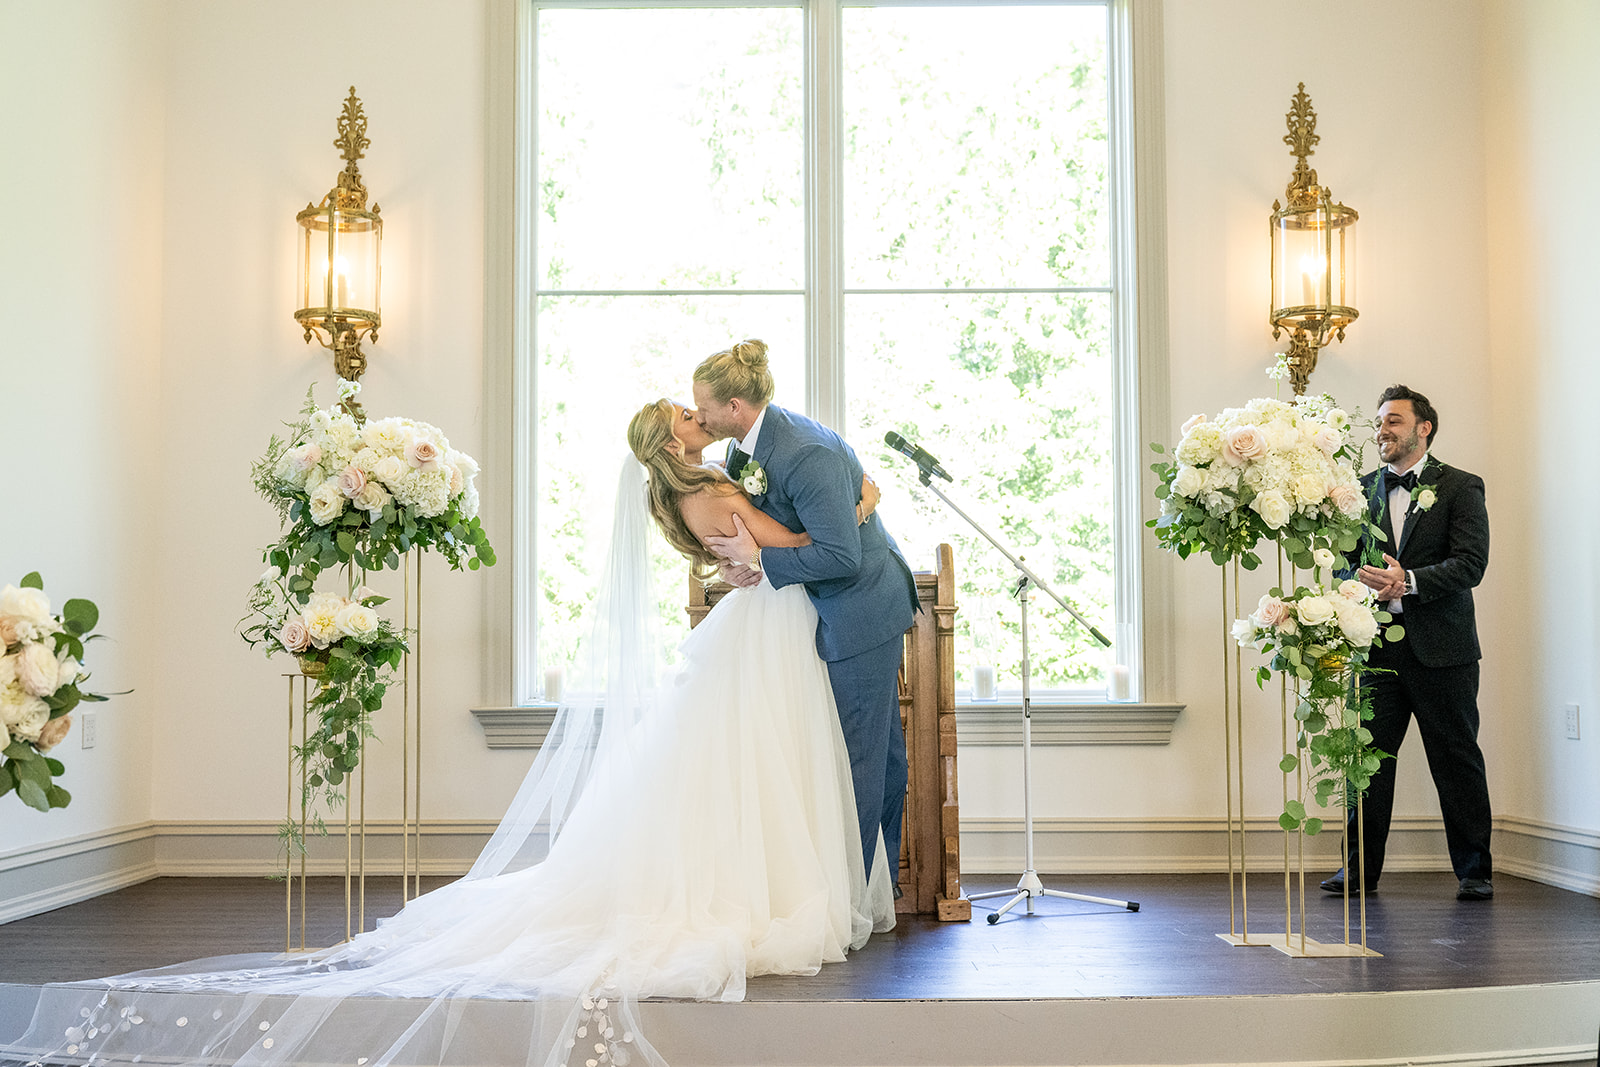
[152,0,526,819]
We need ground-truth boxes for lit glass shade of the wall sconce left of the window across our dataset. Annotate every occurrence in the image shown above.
[294,203,384,330]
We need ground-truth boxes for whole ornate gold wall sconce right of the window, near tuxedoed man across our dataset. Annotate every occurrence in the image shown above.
[1267,82,1360,397]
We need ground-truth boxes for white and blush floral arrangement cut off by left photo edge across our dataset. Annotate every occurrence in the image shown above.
[0,571,106,811]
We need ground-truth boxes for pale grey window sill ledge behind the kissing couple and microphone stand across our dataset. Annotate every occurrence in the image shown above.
[472,701,1184,749]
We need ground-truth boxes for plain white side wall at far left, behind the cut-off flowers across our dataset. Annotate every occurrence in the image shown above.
[0,0,165,853]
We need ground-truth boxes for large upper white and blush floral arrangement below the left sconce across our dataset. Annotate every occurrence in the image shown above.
[251,381,494,605]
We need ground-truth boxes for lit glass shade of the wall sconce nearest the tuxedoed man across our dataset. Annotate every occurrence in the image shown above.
[1272,190,1358,344]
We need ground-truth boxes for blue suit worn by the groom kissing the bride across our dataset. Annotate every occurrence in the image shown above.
[731,405,917,877]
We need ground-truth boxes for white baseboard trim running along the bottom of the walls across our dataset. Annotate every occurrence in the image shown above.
[0,816,1600,923]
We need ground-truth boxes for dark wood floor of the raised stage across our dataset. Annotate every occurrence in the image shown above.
[0,873,1600,1001]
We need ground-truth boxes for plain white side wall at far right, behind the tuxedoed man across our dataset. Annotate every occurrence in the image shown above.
[1485,0,1600,832]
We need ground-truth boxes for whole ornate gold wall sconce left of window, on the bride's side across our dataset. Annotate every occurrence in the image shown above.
[294,85,384,418]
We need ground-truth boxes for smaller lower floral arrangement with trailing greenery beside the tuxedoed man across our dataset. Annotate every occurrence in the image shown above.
[1234,566,1405,835]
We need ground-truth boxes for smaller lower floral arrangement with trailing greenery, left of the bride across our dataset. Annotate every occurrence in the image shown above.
[240,568,406,837]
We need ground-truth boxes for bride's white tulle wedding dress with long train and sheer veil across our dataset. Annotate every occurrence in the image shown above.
[0,461,893,1067]
